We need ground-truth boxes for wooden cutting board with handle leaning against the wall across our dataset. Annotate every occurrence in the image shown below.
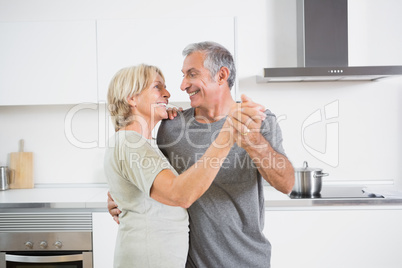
[10,140,34,189]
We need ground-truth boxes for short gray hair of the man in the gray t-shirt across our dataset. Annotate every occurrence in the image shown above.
[183,41,236,89]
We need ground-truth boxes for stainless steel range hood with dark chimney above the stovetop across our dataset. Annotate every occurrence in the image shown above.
[257,0,402,82]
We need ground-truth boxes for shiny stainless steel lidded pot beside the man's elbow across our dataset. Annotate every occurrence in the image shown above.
[291,161,329,196]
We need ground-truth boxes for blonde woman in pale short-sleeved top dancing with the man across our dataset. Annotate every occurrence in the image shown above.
[105,65,242,268]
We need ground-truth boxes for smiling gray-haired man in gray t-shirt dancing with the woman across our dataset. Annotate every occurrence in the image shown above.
[109,42,294,268]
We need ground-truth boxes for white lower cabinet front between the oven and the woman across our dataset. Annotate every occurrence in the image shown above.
[92,212,118,268]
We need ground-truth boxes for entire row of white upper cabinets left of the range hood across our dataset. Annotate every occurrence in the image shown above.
[0,17,237,105]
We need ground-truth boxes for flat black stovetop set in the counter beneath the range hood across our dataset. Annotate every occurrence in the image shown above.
[289,186,384,199]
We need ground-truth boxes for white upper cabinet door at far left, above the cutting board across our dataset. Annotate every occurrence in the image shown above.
[0,21,97,105]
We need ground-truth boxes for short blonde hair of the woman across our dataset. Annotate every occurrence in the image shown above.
[107,64,165,131]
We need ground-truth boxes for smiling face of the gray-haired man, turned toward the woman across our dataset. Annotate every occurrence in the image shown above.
[180,52,219,108]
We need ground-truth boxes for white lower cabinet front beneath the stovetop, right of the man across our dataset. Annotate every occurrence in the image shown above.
[264,209,402,268]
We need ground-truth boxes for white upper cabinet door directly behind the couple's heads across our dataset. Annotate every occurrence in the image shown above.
[97,17,236,102]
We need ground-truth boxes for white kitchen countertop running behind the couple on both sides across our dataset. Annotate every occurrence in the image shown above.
[0,184,402,211]
